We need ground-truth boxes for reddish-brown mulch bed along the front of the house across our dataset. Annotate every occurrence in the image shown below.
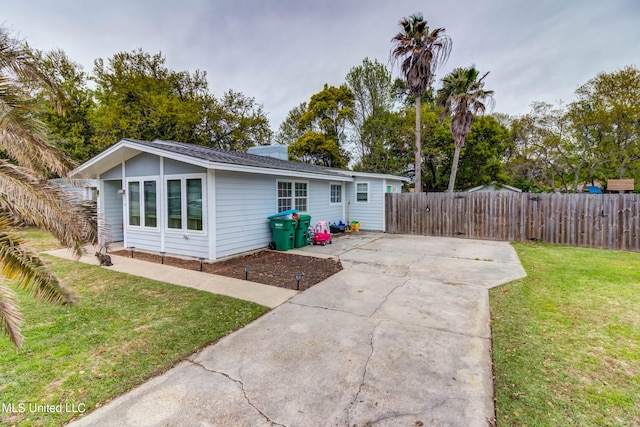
[109,249,342,291]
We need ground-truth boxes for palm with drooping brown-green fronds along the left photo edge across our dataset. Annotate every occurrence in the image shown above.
[0,27,97,347]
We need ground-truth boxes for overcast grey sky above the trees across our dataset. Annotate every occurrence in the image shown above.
[0,0,640,130]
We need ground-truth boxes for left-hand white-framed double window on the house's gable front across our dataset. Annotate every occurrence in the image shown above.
[127,179,158,228]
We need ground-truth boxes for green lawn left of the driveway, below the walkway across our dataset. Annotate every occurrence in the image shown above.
[0,230,268,426]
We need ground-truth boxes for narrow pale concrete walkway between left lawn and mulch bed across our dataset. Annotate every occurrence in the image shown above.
[45,248,299,308]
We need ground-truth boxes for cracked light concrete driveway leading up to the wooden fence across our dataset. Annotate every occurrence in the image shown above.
[74,233,525,426]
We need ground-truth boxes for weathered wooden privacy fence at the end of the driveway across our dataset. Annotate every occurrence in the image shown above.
[385,192,640,251]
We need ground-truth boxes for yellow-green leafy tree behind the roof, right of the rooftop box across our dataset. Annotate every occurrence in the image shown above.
[289,84,354,168]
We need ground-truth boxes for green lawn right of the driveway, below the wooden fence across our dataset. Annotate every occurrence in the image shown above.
[490,244,640,426]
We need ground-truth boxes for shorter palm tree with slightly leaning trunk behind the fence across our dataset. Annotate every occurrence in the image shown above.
[436,65,493,193]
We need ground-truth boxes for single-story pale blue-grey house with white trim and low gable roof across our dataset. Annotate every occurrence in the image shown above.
[73,139,408,260]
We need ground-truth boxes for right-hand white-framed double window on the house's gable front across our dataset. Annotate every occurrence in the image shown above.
[166,177,204,231]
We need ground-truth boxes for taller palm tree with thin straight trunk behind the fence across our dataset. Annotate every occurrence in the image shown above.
[391,13,451,191]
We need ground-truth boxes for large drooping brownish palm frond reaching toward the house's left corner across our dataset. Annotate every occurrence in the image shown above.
[0,160,97,256]
